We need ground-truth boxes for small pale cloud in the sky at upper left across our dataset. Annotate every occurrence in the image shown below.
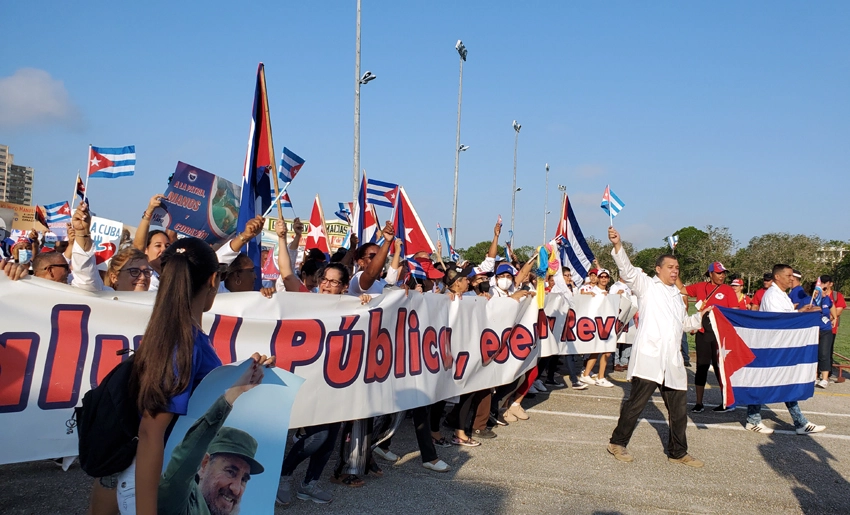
[0,68,82,129]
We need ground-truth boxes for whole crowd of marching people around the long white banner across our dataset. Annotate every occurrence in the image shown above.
[1,195,846,514]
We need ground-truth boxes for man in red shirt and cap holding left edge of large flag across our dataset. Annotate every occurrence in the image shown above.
[676,261,739,413]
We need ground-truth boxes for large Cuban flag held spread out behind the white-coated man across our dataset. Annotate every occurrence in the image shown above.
[710,307,821,406]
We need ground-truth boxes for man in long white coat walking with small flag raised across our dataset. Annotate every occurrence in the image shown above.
[608,227,711,467]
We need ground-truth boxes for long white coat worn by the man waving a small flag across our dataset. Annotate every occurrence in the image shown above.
[611,249,701,391]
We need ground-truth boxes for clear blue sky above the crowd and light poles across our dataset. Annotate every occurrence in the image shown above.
[0,0,850,252]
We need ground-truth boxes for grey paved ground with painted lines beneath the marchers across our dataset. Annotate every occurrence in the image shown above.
[0,370,850,515]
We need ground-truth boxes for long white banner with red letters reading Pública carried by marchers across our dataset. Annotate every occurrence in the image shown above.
[0,275,628,463]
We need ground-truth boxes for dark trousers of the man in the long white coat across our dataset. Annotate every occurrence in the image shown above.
[610,377,688,459]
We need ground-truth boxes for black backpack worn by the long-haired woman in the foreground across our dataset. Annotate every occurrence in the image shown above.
[74,356,141,477]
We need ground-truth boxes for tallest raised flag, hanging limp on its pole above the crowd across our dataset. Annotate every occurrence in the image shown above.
[236,63,276,291]
